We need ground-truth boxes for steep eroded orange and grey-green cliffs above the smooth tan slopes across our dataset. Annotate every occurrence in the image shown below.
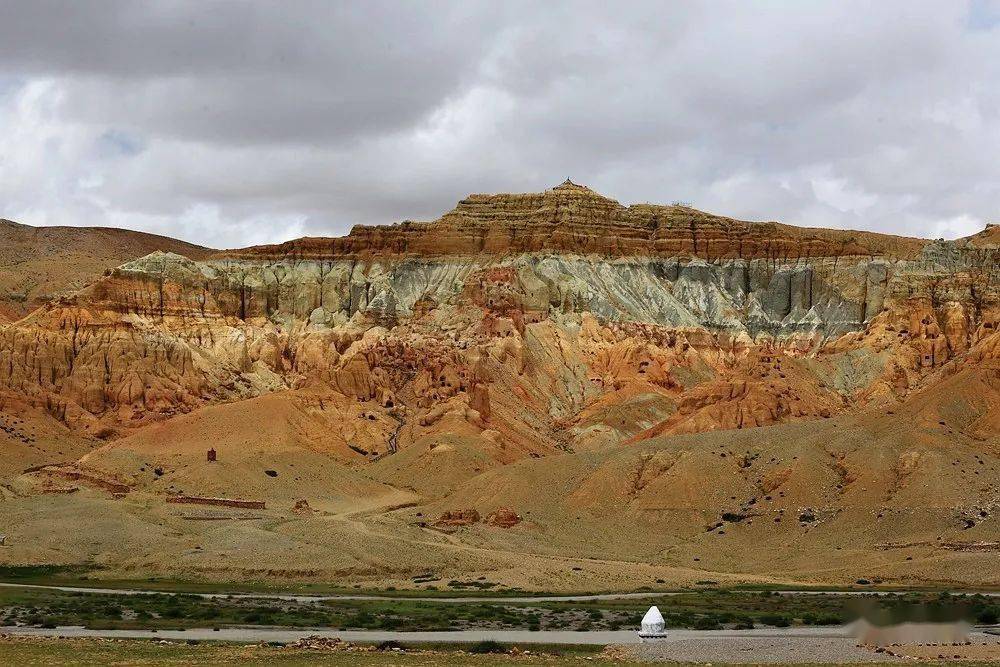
[0,182,1000,460]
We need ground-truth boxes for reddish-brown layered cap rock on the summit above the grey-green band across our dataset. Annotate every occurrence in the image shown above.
[217,181,926,261]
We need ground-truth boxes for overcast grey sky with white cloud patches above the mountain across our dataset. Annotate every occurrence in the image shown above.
[0,0,1000,247]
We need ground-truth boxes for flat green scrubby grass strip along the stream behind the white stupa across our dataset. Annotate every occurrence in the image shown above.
[0,587,1000,631]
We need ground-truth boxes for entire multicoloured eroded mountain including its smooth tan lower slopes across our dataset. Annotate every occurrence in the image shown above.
[0,181,1000,590]
